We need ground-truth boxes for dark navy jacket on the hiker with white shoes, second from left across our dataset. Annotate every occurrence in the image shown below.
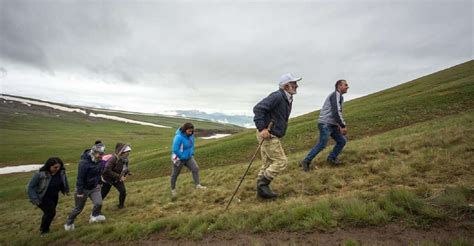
[76,150,102,194]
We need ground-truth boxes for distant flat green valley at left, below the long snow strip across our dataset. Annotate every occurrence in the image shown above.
[0,97,243,167]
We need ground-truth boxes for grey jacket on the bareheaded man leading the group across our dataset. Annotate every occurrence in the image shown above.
[318,91,346,128]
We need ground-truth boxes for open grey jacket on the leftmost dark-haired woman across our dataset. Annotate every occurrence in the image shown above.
[28,170,69,205]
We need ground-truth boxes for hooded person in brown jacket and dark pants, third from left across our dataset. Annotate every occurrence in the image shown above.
[101,143,132,209]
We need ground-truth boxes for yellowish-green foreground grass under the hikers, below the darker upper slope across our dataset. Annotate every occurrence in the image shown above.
[0,109,474,243]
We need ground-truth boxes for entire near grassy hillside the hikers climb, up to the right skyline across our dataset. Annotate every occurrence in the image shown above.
[0,61,474,245]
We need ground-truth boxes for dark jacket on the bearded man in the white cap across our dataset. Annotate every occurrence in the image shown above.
[253,89,291,138]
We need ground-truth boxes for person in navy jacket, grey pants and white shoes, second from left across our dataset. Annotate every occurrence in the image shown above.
[64,143,105,231]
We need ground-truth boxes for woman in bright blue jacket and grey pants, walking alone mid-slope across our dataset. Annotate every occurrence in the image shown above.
[171,123,206,196]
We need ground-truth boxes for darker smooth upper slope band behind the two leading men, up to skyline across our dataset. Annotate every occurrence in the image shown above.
[131,61,474,178]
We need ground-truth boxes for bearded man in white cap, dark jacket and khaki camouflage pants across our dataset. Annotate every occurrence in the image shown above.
[253,73,301,199]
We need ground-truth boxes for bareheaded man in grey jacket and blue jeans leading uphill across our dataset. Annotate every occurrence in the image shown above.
[300,79,349,172]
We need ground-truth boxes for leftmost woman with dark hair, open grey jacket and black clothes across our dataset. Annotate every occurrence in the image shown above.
[28,157,69,235]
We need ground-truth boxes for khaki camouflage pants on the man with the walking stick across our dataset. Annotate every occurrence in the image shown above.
[257,131,288,180]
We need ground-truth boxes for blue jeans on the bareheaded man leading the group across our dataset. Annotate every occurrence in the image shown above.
[304,123,346,161]
